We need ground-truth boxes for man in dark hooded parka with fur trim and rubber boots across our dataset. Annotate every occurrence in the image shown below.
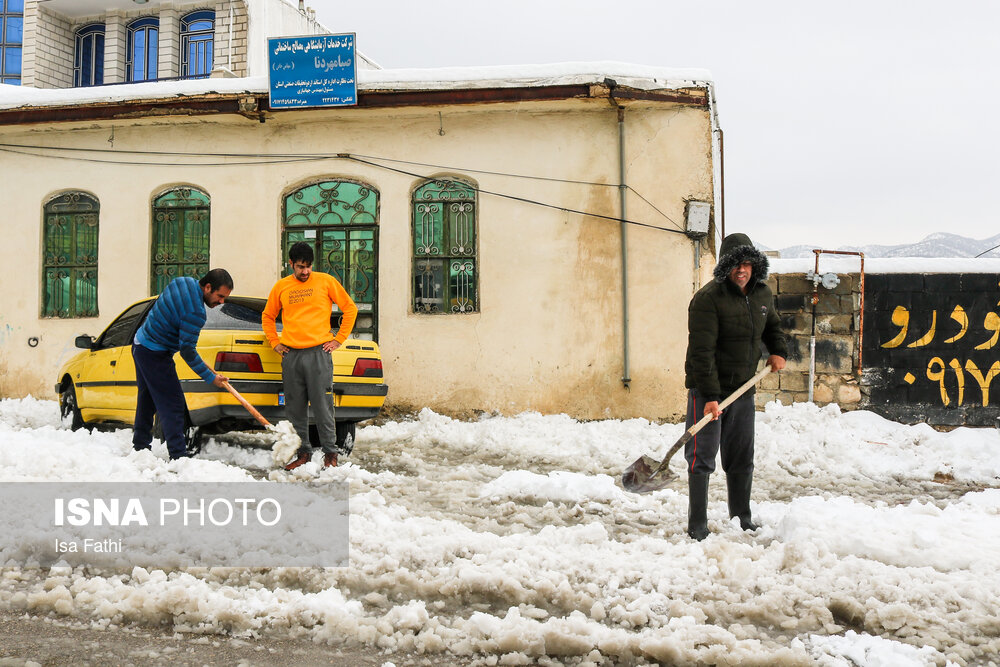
[684,234,788,540]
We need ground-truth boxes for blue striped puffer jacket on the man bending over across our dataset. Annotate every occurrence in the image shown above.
[135,277,215,384]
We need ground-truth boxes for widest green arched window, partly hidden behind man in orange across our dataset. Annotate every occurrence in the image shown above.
[281,180,379,340]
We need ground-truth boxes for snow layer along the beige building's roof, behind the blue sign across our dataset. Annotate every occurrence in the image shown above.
[0,62,712,109]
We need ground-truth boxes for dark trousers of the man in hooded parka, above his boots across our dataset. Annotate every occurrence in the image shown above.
[684,389,756,475]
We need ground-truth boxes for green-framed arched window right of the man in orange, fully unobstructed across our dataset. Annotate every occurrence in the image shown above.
[413,178,479,313]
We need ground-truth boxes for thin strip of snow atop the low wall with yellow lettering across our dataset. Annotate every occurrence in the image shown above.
[769,255,1000,275]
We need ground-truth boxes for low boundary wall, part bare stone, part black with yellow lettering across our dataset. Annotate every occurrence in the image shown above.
[757,272,1000,426]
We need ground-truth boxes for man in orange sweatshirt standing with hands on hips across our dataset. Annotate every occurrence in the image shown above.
[261,241,358,470]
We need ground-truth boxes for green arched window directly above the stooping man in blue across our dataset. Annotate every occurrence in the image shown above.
[149,188,212,296]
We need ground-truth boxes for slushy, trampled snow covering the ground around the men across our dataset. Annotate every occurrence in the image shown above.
[0,398,1000,666]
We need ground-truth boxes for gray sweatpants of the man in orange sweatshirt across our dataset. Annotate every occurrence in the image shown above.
[281,345,337,454]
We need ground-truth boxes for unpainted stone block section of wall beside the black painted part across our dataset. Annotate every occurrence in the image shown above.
[757,273,864,410]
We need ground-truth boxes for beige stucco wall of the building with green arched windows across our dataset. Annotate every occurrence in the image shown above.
[0,95,713,418]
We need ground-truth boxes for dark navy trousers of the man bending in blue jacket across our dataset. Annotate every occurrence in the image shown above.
[132,343,187,459]
